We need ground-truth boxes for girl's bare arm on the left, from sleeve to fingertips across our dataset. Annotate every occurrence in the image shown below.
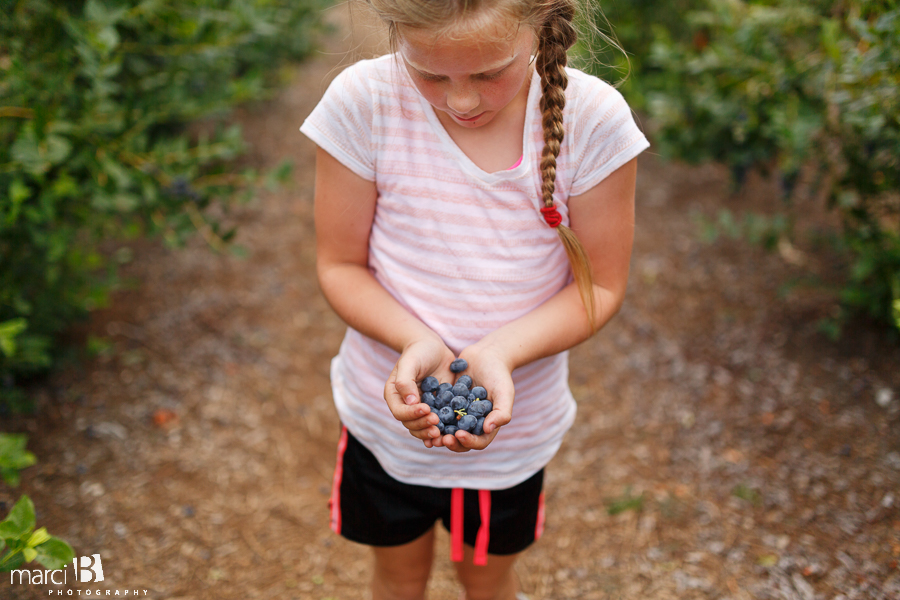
[315,148,455,439]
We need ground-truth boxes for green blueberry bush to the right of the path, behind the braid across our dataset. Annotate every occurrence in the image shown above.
[592,0,900,330]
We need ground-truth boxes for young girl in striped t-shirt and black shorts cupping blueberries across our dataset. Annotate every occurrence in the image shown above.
[301,0,648,600]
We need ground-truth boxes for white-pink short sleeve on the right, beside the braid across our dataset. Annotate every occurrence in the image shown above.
[569,76,650,196]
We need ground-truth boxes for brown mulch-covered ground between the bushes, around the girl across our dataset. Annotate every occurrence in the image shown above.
[0,8,900,600]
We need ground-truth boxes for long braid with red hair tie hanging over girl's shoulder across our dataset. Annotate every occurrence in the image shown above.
[535,0,595,330]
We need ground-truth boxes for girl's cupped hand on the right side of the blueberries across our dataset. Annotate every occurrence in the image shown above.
[434,342,515,452]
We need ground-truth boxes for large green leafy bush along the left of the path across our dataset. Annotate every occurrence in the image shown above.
[0,0,323,410]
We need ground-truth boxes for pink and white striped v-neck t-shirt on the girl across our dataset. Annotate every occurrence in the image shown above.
[300,55,649,489]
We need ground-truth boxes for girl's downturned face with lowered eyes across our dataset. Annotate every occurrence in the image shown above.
[398,19,534,129]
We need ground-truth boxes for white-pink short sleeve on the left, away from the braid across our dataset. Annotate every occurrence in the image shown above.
[300,61,375,181]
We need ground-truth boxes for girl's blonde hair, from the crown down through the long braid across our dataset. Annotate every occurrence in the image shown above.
[365,0,596,331]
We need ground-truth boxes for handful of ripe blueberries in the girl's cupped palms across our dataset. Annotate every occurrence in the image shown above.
[420,358,494,435]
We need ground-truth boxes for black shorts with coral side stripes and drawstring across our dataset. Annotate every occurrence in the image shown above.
[329,427,544,564]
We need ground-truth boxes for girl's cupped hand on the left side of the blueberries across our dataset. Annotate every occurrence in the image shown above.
[384,336,455,448]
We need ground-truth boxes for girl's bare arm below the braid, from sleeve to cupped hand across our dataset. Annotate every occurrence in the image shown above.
[444,159,637,451]
